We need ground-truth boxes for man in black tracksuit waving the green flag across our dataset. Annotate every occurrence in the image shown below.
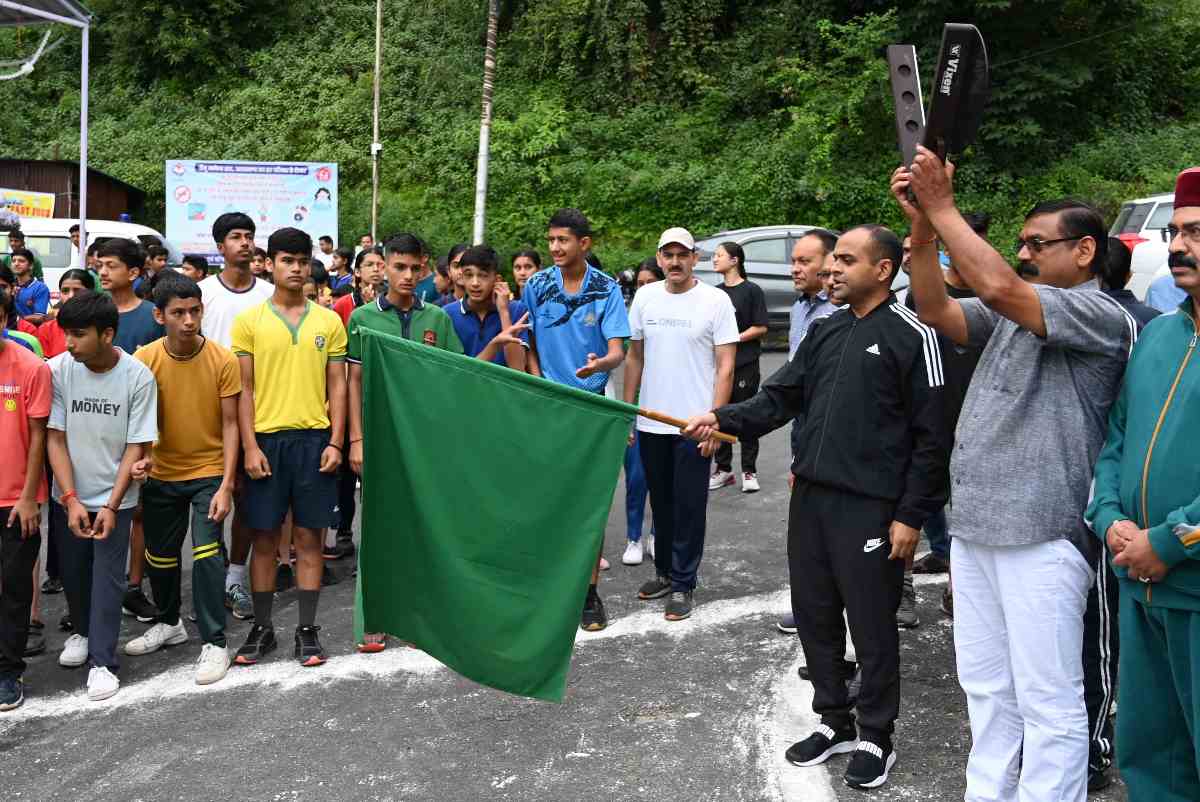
[685,226,952,788]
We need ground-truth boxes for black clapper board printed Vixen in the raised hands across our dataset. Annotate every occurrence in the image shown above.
[906,23,991,164]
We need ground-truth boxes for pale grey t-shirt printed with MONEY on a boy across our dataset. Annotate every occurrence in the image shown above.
[47,349,158,513]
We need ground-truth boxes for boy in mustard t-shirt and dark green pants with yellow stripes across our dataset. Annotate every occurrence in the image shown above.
[125,271,241,686]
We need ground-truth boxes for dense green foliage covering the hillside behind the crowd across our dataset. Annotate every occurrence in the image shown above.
[0,0,1200,268]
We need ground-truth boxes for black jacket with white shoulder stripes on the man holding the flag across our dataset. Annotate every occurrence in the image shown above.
[716,295,954,529]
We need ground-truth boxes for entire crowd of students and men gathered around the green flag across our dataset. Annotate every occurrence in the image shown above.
[0,160,1200,800]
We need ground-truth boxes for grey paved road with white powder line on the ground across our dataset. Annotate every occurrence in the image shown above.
[0,354,1124,802]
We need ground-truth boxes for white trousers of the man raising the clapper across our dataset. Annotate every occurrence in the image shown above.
[950,538,1093,802]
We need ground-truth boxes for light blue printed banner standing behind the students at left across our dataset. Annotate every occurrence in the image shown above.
[166,158,337,264]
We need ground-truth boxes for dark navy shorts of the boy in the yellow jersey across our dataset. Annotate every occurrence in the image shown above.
[241,429,337,531]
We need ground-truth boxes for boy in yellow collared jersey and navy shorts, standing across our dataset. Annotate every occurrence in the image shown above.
[233,228,346,666]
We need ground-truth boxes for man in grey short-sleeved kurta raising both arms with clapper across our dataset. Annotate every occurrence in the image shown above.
[892,149,1136,802]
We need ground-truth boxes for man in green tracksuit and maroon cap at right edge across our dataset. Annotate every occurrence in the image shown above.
[1087,167,1200,802]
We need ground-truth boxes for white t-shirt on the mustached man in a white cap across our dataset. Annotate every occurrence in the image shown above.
[629,281,738,435]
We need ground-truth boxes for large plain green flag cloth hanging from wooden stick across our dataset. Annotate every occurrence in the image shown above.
[358,329,636,701]
